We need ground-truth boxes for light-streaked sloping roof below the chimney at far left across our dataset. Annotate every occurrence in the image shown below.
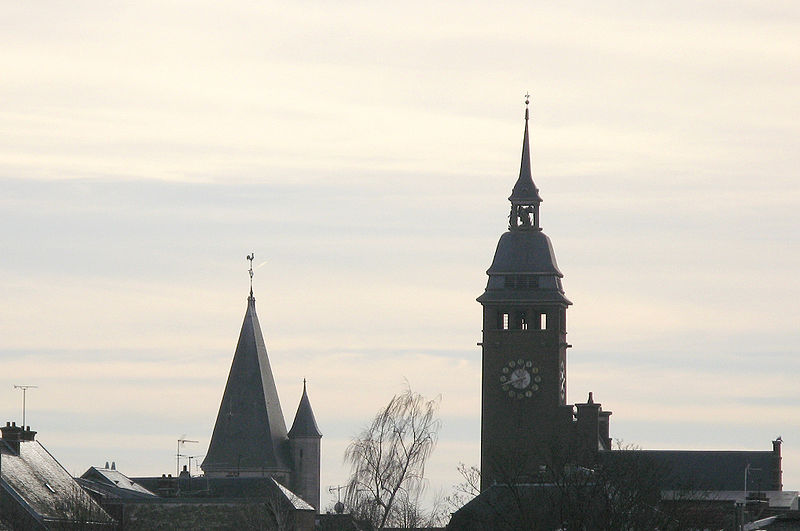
[0,440,112,524]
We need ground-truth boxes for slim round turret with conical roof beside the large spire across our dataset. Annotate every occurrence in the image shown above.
[289,379,322,512]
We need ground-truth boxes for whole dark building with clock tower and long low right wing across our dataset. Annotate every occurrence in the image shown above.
[448,101,784,530]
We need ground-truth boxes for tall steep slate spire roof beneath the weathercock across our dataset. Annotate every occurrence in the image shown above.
[200,295,289,474]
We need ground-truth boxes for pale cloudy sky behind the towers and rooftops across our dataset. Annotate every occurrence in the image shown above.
[0,0,800,507]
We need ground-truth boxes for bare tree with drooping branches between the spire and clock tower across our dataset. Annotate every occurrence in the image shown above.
[345,388,441,529]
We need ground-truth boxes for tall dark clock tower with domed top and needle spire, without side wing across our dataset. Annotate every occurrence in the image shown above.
[478,99,573,490]
